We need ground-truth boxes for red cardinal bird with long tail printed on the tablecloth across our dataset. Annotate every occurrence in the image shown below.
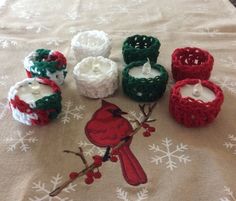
[85,100,147,186]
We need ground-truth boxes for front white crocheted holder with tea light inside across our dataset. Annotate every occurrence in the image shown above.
[73,56,119,98]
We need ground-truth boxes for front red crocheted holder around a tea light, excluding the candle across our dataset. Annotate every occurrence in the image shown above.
[169,79,224,127]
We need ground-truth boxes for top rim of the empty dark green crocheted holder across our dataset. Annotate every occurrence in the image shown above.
[122,34,161,51]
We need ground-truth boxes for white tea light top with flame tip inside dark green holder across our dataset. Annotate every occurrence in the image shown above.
[129,59,161,79]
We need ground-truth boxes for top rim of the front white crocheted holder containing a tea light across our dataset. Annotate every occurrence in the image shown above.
[73,56,118,81]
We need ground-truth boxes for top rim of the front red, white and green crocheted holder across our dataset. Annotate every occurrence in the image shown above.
[8,77,61,106]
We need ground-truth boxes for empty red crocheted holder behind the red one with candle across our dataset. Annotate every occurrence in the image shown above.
[172,47,214,81]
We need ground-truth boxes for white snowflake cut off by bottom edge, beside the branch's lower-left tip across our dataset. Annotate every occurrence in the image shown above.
[29,174,77,201]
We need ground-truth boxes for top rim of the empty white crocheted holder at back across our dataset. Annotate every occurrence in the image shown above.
[71,30,111,51]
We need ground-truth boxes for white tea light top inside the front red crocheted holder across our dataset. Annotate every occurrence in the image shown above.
[180,83,216,102]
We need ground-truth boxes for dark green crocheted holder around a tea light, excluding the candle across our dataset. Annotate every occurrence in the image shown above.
[122,61,169,102]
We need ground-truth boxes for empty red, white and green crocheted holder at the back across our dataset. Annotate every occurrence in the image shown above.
[24,49,67,85]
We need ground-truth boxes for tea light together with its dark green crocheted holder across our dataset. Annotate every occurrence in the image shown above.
[122,60,168,102]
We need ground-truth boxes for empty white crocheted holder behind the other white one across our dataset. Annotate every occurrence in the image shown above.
[71,30,111,61]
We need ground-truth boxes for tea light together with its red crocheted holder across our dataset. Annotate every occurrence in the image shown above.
[169,79,224,127]
